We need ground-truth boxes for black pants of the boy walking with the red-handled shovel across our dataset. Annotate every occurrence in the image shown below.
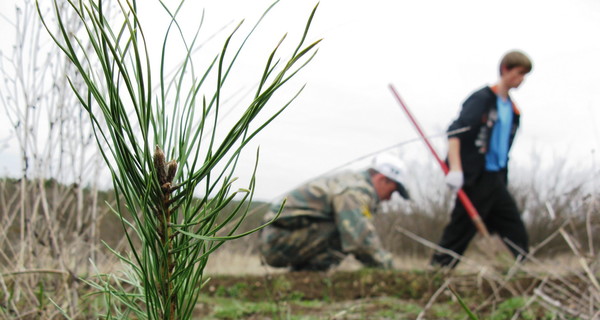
[431,172,529,268]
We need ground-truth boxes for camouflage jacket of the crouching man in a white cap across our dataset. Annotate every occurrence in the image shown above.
[272,171,391,267]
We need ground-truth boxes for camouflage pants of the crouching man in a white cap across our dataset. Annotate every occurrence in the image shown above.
[260,220,344,270]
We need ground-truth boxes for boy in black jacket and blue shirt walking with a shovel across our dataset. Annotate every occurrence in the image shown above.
[431,51,532,268]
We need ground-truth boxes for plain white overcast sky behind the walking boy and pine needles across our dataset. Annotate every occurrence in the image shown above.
[0,0,600,200]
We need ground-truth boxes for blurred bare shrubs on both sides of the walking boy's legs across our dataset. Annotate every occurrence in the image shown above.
[376,156,600,257]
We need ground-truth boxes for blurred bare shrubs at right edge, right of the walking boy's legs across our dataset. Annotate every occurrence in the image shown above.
[509,159,600,256]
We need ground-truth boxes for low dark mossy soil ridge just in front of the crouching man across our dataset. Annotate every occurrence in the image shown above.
[204,269,540,301]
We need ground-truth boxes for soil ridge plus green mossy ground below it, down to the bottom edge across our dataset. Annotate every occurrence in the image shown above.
[197,269,586,319]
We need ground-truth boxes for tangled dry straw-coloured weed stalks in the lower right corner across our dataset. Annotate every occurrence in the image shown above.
[397,191,600,319]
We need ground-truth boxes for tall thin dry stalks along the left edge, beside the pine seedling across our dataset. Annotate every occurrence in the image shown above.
[0,1,108,319]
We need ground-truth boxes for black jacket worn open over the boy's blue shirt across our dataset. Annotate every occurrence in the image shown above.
[448,86,520,186]
